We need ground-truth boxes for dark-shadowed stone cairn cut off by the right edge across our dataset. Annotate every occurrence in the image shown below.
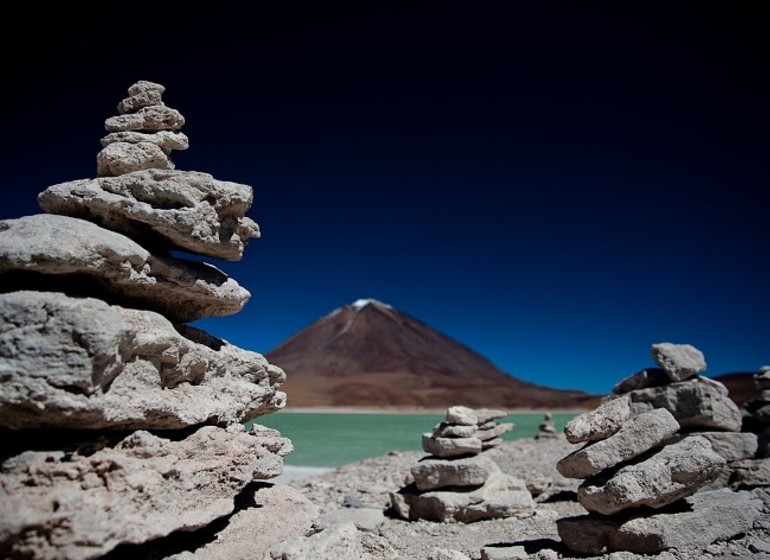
[730,366,770,488]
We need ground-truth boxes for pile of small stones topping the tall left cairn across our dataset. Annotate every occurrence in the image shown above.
[96,81,189,177]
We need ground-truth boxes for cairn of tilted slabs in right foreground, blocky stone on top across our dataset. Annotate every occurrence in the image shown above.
[557,343,759,555]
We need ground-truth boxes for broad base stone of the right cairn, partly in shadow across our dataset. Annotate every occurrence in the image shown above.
[556,490,761,555]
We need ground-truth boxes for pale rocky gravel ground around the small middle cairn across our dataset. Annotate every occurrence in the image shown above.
[283,434,770,560]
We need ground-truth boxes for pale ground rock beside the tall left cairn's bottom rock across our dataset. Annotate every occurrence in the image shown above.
[168,485,318,560]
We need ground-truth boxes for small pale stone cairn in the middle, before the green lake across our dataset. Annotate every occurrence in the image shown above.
[390,406,535,523]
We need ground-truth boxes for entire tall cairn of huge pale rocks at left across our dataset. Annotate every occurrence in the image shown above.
[0,82,291,559]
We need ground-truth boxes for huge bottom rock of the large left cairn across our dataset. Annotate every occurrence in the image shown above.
[0,426,283,559]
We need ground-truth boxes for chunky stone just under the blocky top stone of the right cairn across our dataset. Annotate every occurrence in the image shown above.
[627,376,743,432]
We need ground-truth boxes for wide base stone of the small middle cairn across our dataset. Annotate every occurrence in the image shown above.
[391,472,535,523]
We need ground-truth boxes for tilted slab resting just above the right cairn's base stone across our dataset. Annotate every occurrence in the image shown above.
[577,436,726,515]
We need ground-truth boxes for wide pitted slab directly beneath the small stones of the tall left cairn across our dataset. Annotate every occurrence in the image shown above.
[38,169,259,260]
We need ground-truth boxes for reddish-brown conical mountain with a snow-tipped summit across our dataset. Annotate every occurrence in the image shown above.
[266,300,598,409]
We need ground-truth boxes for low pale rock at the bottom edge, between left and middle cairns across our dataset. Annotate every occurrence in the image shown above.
[270,523,398,560]
